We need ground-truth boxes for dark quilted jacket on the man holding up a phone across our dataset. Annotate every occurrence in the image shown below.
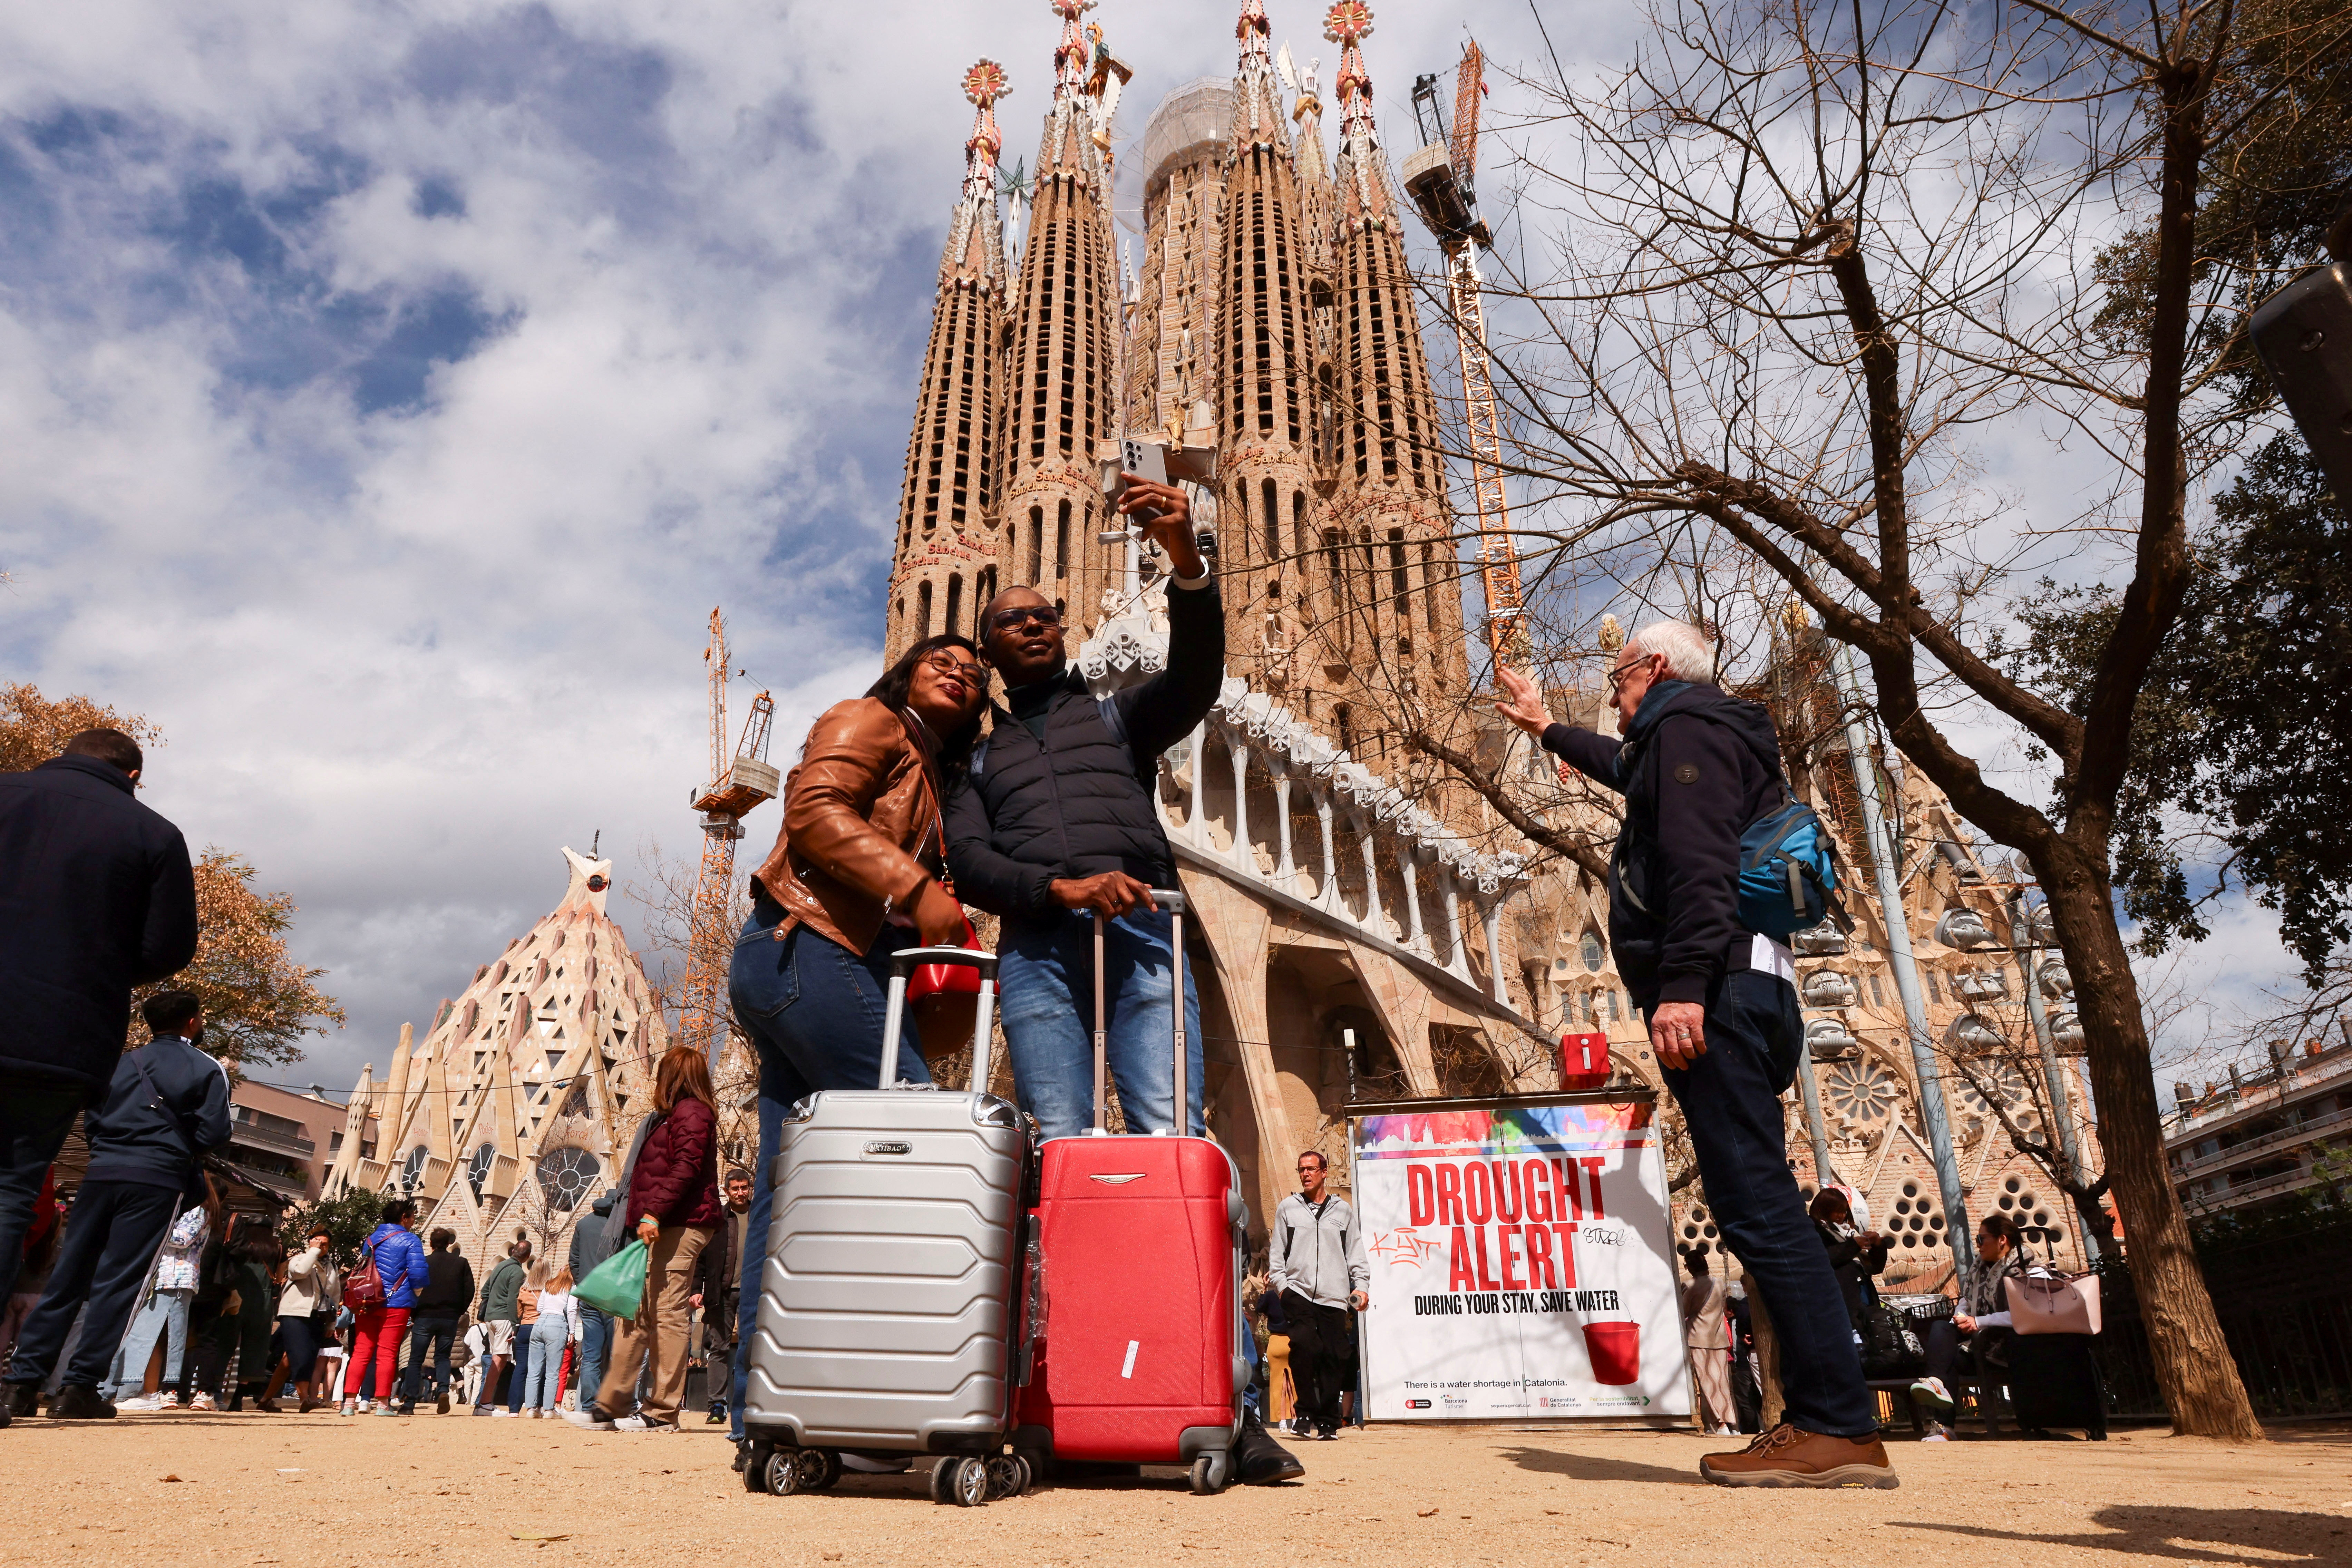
[945,583,1225,917]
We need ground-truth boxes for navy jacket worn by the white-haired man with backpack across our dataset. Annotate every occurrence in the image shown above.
[1543,679,1780,1013]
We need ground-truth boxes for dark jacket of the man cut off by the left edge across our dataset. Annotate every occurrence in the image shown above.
[0,757,195,1102]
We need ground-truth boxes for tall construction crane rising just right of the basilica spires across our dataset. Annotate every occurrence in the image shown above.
[1404,40,1526,665]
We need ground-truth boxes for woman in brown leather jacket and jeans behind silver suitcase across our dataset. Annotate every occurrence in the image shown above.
[727,635,988,1441]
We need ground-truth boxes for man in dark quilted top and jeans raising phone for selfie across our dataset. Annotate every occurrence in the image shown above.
[948,475,1225,1138]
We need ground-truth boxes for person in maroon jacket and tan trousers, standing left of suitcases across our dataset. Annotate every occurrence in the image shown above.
[581,1046,720,1432]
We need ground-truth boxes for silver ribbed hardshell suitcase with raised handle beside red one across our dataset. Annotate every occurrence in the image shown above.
[743,947,1035,1507]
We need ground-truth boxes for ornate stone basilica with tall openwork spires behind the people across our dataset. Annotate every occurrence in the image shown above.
[322,0,2096,1279]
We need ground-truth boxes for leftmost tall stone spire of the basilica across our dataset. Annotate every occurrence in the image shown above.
[884,59,1011,658]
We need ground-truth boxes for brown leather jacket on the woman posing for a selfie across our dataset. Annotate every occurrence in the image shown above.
[760,696,941,952]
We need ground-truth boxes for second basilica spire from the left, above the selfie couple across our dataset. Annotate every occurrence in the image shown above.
[997,0,1119,646]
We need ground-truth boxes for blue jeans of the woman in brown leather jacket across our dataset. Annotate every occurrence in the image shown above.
[727,898,931,1441]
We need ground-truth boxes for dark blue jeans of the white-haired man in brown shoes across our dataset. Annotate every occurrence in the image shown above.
[1663,968,1879,1436]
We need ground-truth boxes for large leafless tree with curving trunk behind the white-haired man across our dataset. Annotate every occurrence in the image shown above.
[1392,0,2343,1439]
